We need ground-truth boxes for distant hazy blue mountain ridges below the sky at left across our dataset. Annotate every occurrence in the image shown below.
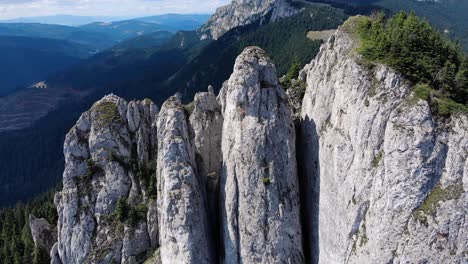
[0,14,208,96]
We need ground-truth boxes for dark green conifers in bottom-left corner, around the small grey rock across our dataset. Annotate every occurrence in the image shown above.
[0,190,57,264]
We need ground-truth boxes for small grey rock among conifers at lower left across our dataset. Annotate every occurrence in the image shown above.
[29,215,57,252]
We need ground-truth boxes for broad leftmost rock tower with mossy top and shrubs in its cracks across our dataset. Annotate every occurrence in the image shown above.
[52,95,158,264]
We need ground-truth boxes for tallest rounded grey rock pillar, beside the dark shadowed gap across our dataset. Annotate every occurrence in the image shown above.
[219,47,304,263]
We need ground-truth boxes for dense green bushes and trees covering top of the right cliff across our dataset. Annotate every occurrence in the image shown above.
[356,12,468,116]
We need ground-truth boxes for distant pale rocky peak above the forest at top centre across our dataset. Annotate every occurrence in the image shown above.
[199,0,299,40]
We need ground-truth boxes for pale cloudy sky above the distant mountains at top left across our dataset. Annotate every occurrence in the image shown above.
[0,0,231,20]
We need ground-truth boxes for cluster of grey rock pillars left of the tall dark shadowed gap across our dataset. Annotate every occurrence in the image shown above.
[51,47,304,263]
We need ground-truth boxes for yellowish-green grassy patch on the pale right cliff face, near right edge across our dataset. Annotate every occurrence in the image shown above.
[414,184,464,223]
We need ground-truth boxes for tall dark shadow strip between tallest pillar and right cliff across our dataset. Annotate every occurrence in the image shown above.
[296,117,320,264]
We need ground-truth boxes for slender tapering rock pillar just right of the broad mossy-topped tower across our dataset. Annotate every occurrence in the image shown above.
[157,96,212,264]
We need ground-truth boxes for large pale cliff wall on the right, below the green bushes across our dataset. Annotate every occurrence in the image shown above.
[299,18,468,263]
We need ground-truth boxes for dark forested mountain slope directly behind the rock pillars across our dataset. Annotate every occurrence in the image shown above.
[0,0,466,217]
